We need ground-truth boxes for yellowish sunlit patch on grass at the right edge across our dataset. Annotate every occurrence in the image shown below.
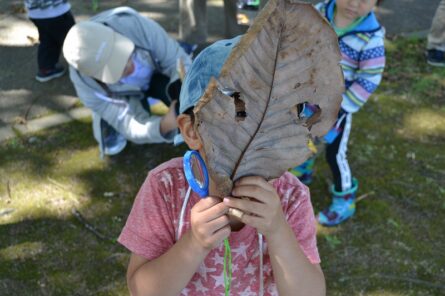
[399,109,445,137]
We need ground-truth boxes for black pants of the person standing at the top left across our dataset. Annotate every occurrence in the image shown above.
[31,11,75,71]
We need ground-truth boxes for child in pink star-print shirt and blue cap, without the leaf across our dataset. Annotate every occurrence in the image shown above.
[119,38,324,295]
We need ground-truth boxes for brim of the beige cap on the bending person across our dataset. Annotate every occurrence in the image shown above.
[96,32,134,84]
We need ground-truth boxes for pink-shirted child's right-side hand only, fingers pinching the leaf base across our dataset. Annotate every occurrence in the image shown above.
[224,177,287,237]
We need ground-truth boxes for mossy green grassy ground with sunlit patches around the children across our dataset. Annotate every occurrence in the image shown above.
[0,39,445,295]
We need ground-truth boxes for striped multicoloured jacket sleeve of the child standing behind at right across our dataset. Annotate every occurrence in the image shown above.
[342,34,385,113]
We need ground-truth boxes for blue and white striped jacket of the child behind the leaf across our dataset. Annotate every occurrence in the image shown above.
[315,0,385,113]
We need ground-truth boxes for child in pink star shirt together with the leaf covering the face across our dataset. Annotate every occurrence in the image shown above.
[119,0,343,296]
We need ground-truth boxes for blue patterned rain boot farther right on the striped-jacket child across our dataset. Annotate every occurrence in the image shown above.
[317,179,358,226]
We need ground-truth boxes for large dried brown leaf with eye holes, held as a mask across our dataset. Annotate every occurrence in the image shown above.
[195,0,344,195]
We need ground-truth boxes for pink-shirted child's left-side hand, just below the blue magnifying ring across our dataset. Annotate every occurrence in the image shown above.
[191,196,230,251]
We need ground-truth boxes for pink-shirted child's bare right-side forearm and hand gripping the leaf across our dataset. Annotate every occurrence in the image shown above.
[224,177,326,296]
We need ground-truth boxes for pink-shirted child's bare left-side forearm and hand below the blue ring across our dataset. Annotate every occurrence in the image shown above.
[127,197,230,296]
